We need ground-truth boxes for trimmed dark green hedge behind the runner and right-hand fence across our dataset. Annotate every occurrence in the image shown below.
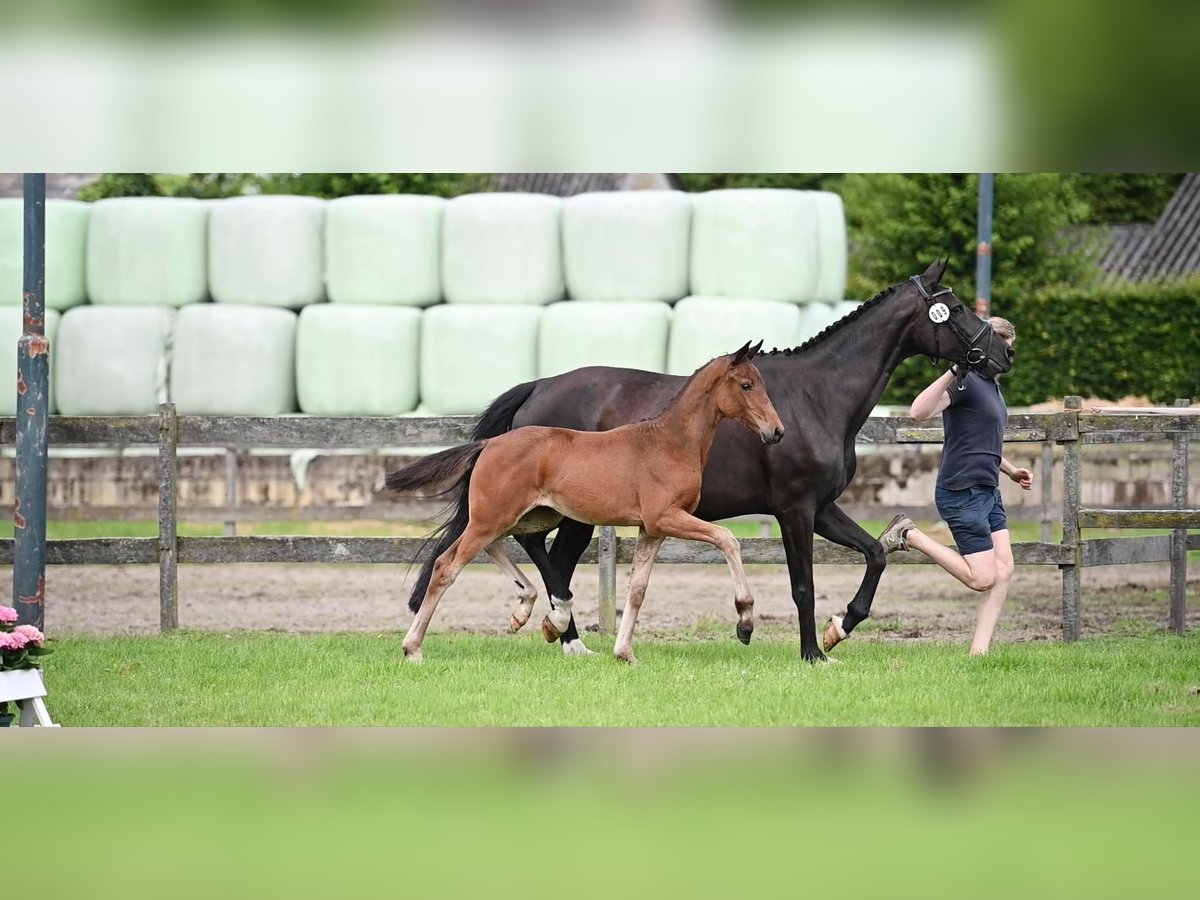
[882,280,1200,406]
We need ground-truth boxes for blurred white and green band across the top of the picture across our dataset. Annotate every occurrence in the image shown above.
[0,0,1200,172]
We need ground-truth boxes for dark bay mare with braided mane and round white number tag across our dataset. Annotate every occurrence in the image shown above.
[410,260,1013,661]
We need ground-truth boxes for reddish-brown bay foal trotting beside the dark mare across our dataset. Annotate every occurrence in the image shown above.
[388,341,784,664]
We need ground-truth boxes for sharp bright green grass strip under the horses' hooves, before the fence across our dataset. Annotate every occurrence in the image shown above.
[37,632,1200,726]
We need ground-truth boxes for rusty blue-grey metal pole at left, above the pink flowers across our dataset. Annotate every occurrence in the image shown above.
[12,174,50,628]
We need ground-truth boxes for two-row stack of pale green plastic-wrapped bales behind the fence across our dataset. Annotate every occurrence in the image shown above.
[0,190,857,416]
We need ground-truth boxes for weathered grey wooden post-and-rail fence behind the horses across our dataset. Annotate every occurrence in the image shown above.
[0,397,1200,641]
